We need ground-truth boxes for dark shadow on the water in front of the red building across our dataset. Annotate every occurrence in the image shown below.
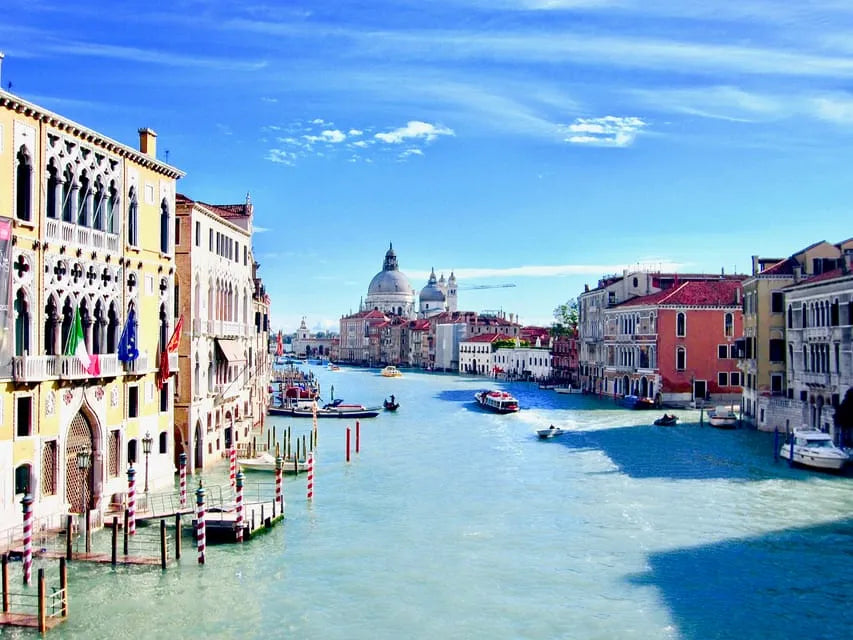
[557,423,844,480]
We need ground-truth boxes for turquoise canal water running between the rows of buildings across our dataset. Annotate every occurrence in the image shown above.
[8,367,853,640]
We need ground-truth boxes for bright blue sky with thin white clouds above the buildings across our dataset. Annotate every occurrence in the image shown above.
[0,0,853,330]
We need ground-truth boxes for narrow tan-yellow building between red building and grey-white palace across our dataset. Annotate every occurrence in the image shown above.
[739,241,849,431]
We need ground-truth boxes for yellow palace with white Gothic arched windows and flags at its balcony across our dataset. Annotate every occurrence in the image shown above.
[0,90,183,529]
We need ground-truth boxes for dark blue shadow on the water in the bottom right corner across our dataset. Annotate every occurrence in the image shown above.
[630,519,853,640]
